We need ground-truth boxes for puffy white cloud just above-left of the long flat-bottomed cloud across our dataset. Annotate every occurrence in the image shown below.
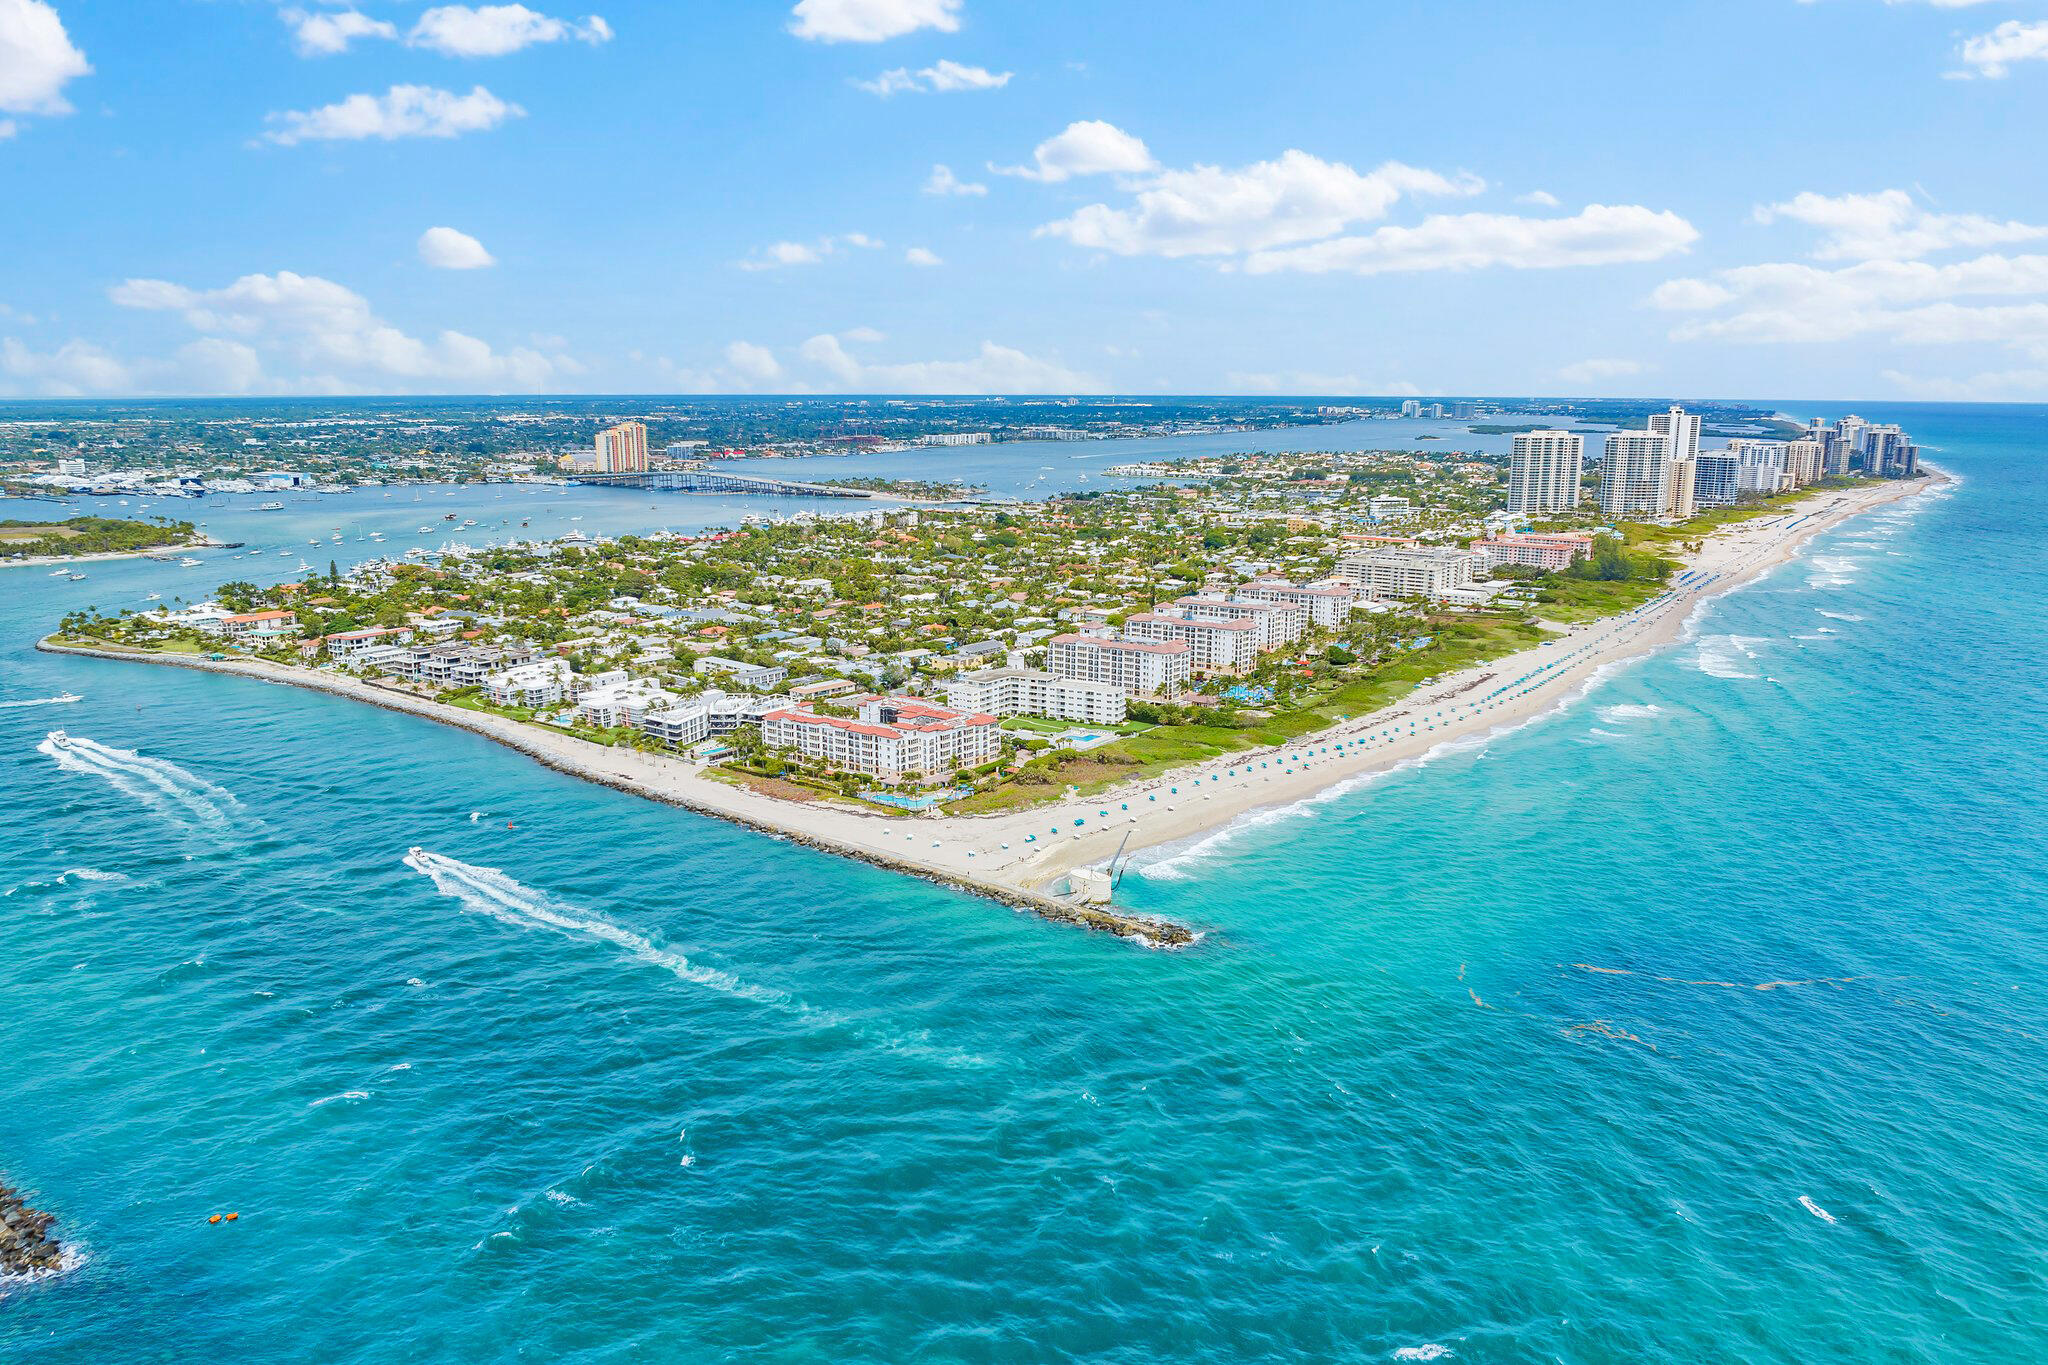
[1038,147,1485,256]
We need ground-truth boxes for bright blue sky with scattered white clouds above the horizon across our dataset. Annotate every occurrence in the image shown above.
[0,0,2048,399]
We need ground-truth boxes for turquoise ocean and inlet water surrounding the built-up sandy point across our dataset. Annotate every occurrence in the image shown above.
[0,407,2048,1363]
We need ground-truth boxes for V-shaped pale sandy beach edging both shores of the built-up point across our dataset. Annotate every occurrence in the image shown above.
[43,473,1946,943]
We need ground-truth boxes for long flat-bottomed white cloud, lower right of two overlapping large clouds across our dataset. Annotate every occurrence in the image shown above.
[1245,205,1700,274]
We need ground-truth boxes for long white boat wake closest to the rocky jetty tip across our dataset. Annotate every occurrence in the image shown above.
[403,849,981,1066]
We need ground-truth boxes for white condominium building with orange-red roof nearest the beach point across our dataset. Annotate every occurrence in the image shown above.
[762,696,1001,782]
